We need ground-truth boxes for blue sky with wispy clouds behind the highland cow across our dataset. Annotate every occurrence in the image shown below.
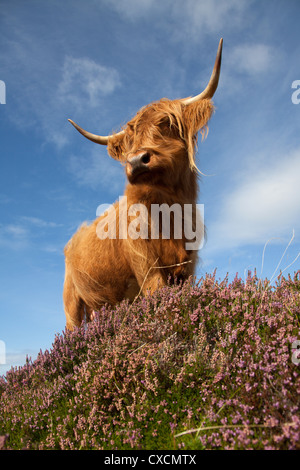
[0,0,300,373]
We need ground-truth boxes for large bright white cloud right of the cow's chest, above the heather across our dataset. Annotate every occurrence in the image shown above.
[208,148,300,251]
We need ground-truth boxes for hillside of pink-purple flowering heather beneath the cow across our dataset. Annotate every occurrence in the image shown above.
[0,271,300,450]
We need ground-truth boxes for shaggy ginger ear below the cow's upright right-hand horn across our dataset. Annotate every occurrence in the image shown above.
[183,99,214,137]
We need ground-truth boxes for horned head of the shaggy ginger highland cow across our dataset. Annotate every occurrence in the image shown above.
[69,39,223,185]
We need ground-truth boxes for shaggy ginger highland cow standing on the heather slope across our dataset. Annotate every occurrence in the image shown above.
[63,39,222,330]
